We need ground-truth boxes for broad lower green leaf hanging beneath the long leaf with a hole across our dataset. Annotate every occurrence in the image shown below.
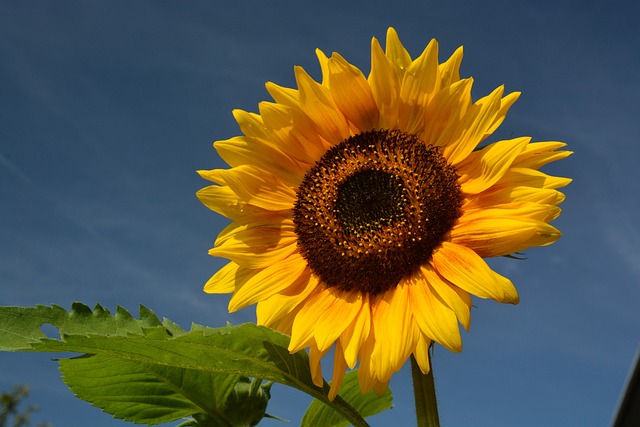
[59,354,240,426]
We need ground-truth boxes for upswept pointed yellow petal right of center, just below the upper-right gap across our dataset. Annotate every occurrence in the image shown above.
[458,137,531,194]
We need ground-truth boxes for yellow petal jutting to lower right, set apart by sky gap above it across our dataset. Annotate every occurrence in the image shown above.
[433,242,517,302]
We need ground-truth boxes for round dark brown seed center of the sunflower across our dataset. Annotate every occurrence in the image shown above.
[293,130,462,295]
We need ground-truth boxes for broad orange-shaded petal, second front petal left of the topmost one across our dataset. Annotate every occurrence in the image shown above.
[328,53,379,132]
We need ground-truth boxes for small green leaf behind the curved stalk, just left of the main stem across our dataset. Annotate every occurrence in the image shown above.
[300,371,393,427]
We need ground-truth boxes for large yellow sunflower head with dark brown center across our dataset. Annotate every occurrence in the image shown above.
[198,28,571,399]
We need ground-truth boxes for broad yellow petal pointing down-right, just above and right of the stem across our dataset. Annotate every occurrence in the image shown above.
[409,274,462,352]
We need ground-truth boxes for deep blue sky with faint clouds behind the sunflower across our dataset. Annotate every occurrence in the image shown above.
[0,0,640,427]
